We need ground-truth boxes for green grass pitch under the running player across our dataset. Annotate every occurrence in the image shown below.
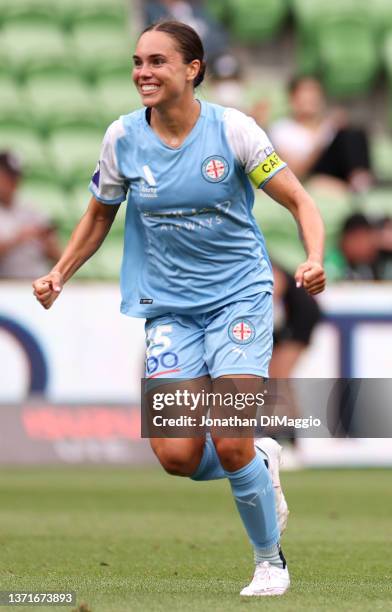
[0,467,392,612]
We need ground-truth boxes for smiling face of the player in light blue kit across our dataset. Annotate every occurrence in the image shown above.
[132,30,200,107]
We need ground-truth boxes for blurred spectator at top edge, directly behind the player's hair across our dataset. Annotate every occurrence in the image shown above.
[143,0,228,72]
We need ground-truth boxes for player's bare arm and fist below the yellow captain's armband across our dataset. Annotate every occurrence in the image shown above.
[263,167,326,295]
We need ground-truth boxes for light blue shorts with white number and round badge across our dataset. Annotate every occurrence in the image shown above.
[145,293,273,379]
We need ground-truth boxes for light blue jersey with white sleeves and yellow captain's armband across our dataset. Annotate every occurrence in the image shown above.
[90,102,286,318]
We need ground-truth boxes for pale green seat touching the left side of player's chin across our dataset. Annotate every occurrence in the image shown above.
[95,75,141,122]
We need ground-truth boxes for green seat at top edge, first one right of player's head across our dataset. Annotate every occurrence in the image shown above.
[230,0,287,45]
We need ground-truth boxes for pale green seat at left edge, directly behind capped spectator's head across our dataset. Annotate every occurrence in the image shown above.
[0,121,48,175]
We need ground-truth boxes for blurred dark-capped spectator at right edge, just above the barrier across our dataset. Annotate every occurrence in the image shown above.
[325,213,392,281]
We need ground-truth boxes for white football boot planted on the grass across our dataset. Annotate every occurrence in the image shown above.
[240,561,290,597]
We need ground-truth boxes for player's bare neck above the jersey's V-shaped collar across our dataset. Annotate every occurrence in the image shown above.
[151,98,200,147]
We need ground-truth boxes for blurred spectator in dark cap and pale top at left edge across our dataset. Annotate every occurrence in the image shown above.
[0,152,60,279]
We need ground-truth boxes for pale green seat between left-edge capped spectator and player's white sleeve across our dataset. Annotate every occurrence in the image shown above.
[48,123,104,186]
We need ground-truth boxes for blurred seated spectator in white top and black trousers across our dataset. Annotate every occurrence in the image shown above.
[269,77,372,192]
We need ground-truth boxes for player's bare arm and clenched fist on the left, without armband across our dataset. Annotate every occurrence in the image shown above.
[33,197,119,308]
